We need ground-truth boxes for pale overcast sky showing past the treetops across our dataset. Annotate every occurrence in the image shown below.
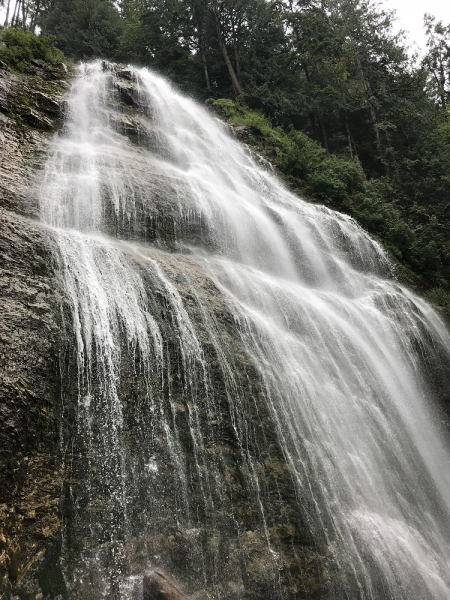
[0,0,450,54]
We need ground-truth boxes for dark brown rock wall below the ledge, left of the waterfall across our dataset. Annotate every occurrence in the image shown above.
[0,209,63,595]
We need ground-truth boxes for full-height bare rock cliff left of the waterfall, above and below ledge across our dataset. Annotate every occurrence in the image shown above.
[0,65,69,598]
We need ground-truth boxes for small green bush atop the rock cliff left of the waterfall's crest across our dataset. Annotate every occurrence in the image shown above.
[0,27,66,73]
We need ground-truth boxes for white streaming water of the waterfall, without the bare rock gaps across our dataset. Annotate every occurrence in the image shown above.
[40,63,450,600]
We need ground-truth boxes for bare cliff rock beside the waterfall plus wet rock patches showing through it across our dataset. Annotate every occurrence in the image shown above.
[0,65,330,600]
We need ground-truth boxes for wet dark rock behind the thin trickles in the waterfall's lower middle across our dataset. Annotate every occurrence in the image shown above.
[54,247,326,600]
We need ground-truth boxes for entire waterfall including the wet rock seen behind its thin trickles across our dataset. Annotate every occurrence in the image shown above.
[40,63,450,600]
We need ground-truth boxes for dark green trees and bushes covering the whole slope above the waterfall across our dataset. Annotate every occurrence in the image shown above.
[3,0,450,304]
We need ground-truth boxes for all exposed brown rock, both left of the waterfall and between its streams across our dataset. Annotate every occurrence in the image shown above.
[0,65,329,600]
